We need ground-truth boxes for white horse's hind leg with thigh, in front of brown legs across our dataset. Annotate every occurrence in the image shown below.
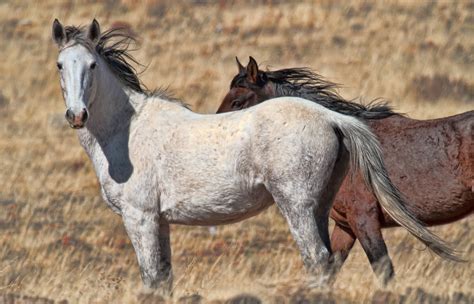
[265,130,347,285]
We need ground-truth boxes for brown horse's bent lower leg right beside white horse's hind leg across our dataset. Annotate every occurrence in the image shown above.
[331,224,356,274]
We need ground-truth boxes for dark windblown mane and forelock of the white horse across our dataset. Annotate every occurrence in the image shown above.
[65,26,188,107]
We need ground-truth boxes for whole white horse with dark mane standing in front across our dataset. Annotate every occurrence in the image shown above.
[53,20,456,288]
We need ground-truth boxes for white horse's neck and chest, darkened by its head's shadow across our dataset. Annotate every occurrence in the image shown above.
[78,60,146,183]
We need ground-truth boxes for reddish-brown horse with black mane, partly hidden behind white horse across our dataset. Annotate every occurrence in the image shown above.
[217,57,474,284]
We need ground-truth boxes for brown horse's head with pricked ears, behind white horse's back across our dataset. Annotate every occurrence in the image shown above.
[217,57,275,113]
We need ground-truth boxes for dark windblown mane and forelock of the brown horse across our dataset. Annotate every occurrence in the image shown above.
[231,68,400,119]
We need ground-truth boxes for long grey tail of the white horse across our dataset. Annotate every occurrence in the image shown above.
[330,115,463,261]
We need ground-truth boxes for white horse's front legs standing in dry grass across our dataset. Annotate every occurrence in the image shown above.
[122,209,172,293]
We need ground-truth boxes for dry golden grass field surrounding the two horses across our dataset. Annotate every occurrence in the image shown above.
[0,0,474,303]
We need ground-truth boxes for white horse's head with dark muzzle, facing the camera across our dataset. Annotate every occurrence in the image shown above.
[52,19,100,129]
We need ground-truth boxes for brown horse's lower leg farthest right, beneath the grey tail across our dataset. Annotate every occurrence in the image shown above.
[349,207,394,285]
